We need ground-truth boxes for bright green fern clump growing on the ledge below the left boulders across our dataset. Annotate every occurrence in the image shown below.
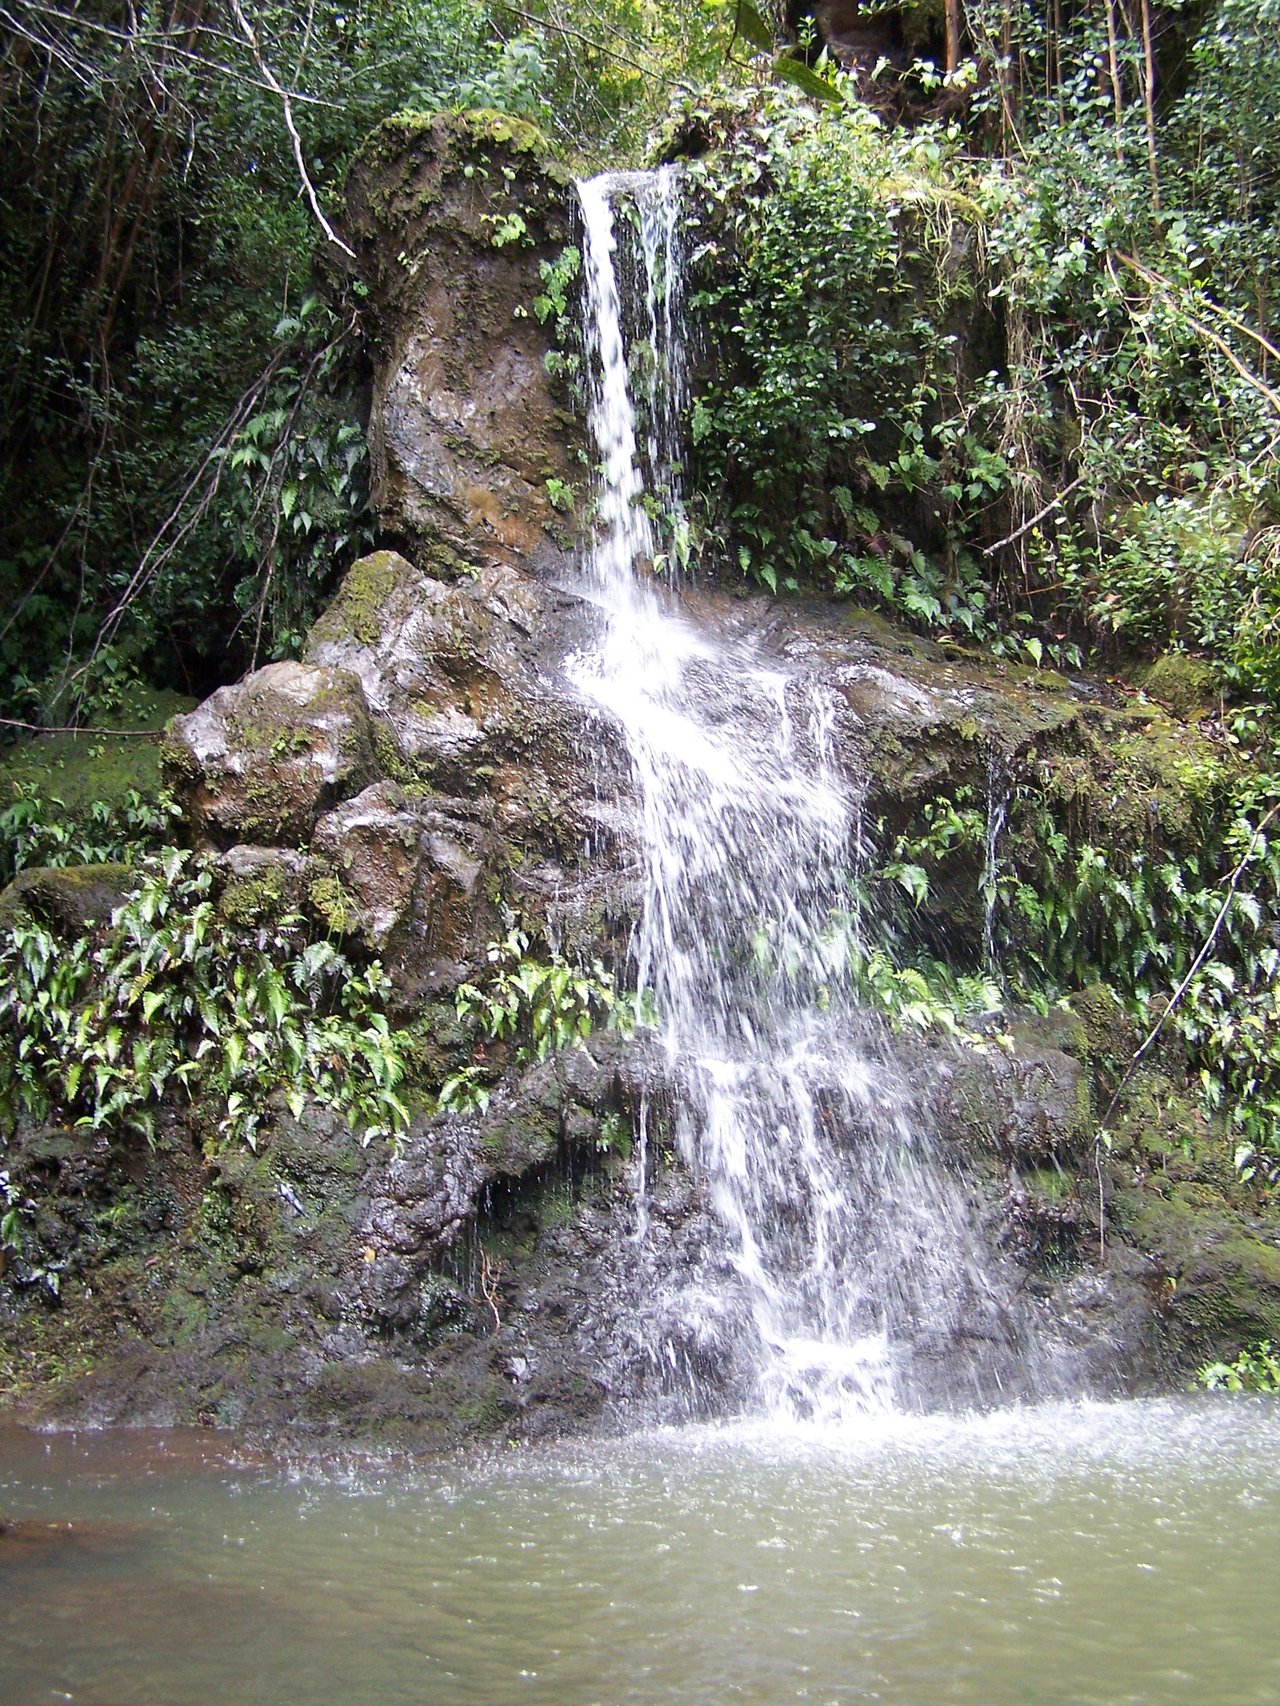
[0,848,410,1148]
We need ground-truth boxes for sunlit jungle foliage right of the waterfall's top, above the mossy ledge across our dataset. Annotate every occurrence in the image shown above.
[686,3,1280,703]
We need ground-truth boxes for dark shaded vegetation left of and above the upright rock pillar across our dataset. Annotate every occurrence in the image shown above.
[0,0,730,723]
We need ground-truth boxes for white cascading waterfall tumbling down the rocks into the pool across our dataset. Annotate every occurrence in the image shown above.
[570,169,1064,1419]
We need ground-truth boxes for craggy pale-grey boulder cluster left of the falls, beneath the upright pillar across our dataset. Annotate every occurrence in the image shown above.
[167,551,630,1007]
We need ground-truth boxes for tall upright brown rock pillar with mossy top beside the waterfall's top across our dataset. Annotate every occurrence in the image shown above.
[348,113,575,573]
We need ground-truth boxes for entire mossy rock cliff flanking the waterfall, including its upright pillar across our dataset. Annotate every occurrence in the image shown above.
[0,116,1280,1445]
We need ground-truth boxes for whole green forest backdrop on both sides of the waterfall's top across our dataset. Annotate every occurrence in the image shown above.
[0,0,1280,725]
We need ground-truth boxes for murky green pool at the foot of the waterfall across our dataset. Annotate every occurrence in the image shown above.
[0,1399,1280,1706]
